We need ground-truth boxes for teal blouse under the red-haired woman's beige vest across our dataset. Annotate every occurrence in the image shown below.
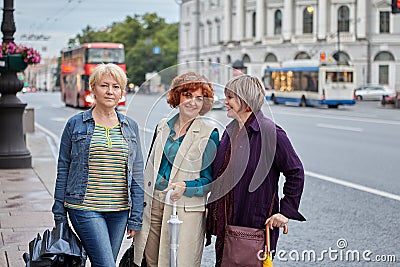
[155,116,219,197]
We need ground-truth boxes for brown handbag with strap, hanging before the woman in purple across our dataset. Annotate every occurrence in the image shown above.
[221,194,275,267]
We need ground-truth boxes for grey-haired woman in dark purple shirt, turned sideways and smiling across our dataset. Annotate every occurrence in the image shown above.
[207,75,305,266]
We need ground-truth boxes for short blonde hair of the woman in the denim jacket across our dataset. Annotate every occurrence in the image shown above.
[89,63,128,91]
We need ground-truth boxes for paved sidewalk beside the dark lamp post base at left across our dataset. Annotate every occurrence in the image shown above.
[0,131,56,267]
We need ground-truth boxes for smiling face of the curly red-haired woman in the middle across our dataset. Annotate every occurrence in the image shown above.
[179,88,204,118]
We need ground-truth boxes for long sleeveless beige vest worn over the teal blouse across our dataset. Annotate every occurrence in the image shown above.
[134,117,214,266]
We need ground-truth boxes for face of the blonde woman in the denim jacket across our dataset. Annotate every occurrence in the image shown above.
[92,74,123,108]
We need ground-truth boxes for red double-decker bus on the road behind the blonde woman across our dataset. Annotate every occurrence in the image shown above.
[60,43,126,107]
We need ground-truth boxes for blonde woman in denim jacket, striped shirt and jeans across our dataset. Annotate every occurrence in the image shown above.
[52,63,143,267]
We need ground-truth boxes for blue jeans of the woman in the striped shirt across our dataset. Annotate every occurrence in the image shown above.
[68,209,129,267]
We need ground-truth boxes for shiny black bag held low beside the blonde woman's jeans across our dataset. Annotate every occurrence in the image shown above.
[23,223,86,267]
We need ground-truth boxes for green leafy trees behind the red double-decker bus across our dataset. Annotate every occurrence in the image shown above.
[69,13,178,85]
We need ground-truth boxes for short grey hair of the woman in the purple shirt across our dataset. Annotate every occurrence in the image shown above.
[225,74,265,112]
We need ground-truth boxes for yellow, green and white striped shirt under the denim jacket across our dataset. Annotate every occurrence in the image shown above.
[65,124,129,212]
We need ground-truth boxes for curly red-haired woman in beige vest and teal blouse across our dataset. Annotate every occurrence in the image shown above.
[134,72,219,267]
